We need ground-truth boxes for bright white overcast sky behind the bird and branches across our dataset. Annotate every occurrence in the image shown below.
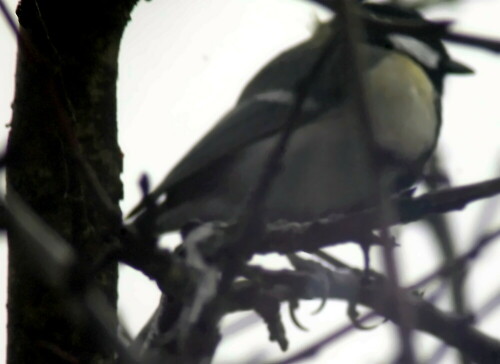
[0,0,500,363]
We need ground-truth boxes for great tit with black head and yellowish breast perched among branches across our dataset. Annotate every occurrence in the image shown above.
[130,4,470,234]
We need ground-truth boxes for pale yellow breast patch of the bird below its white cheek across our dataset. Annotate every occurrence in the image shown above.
[366,52,440,161]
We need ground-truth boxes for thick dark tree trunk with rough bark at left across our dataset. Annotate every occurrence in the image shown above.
[7,0,136,364]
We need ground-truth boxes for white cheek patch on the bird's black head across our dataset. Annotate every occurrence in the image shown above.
[387,33,441,69]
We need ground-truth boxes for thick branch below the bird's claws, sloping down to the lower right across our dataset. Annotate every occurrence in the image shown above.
[226,269,500,363]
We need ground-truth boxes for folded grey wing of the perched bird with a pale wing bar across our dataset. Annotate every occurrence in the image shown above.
[129,37,381,216]
